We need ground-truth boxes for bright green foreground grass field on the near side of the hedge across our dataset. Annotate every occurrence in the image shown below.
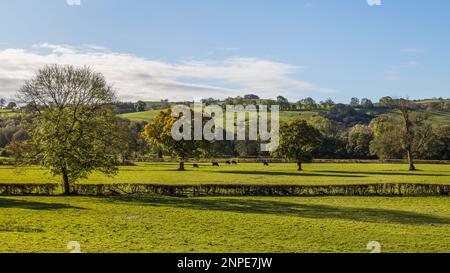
[0,197,450,253]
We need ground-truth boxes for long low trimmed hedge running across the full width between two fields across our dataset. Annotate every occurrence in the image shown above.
[0,183,450,197]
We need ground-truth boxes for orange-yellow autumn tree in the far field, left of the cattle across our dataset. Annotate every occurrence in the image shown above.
[143,109,208,171]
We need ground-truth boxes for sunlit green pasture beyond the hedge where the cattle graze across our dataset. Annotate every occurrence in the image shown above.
[0,163,450,185]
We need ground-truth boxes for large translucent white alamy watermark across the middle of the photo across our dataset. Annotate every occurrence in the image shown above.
[172,103,280,152]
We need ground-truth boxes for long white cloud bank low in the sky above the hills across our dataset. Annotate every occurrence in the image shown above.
[0,44,334,100]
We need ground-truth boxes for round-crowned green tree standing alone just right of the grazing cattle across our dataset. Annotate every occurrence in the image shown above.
[274,119,322,171]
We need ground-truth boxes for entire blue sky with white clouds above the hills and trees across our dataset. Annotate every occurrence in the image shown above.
[0,0,450,102]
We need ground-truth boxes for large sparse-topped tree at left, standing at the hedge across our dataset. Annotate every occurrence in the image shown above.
[12,65,123,195]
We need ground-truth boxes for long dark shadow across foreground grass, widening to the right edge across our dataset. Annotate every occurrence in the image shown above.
[108,196,450,225]
